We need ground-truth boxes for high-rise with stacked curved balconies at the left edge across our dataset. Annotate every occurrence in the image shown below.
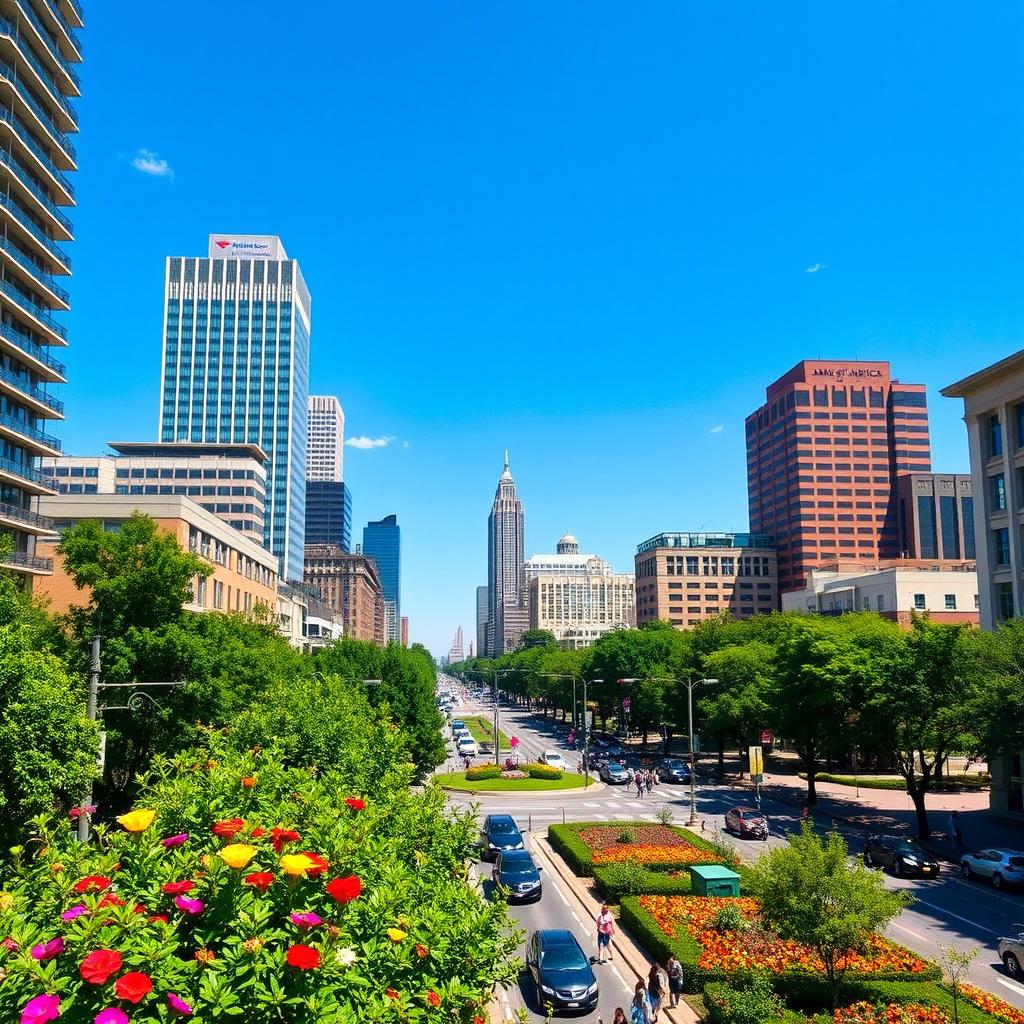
[0,0,82,575]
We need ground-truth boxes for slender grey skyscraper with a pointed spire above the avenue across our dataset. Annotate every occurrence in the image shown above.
[487,452,526,657]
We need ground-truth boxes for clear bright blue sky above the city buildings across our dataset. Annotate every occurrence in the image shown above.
[61,0,1024,652]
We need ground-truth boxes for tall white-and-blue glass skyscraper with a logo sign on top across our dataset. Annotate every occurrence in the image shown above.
[160,234,310,581]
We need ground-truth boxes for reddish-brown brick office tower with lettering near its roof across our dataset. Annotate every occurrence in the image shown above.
[746,359,932,593]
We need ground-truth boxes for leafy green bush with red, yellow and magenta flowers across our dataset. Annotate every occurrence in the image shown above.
[0,736,515,1024]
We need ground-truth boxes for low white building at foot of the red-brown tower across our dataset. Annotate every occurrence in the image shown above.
[782,559,978,626]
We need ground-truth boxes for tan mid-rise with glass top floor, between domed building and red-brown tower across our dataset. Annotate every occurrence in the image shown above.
[634,534,778,629]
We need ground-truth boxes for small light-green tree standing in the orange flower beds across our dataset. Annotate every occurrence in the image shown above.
[751,822,912,1009]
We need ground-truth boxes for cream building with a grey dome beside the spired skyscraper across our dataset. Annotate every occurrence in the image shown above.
[523,534,636,649]
